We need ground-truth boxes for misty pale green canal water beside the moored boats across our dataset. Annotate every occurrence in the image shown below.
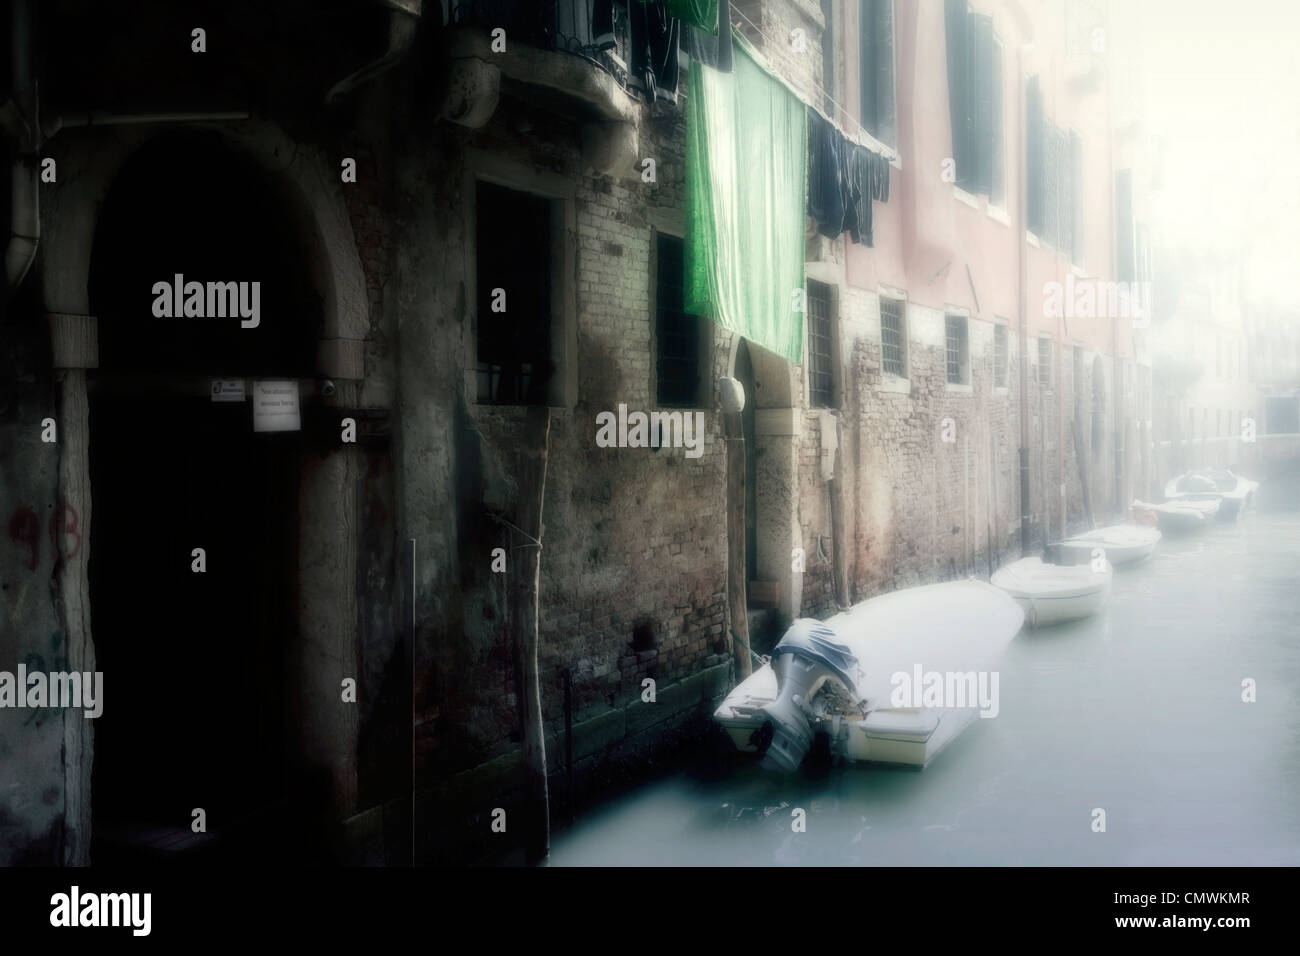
[551,475,1300,866]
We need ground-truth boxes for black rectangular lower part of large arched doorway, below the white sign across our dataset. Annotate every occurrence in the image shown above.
[90,392,298,862]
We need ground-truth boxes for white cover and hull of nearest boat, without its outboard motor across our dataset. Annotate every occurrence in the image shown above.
[714,580,1024,767]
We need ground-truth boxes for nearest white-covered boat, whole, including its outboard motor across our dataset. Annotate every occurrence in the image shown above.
[714,580,1024,771]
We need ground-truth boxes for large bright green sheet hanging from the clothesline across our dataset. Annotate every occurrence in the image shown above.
[685,39,807,363]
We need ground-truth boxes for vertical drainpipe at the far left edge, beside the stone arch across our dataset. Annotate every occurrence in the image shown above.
[4,0,40,300]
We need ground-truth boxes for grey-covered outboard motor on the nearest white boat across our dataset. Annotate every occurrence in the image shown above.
[762,618,858,773]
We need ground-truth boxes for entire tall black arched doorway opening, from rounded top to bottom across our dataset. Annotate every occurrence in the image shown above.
[87,133,322,862]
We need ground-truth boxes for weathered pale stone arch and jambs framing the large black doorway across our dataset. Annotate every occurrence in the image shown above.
[40,120,369,865]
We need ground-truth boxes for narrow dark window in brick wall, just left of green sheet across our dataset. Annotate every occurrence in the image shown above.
[655,233,701,408]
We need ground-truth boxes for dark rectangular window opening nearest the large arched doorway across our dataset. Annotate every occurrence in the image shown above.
[476,182,555,405]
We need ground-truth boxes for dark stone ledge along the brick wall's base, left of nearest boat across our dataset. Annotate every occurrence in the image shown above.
[417,654,732,842]
